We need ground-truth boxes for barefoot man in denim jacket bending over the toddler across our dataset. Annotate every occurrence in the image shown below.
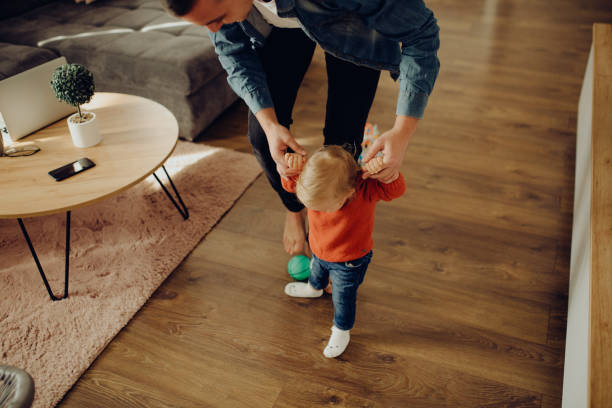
[162,0,440,254]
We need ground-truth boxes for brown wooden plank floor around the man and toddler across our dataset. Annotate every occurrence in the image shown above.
[60,0,612,408]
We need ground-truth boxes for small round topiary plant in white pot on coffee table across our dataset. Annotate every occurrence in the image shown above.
[51,64,101,147]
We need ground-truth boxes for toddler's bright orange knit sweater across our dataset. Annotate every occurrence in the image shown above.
[281,173,406,262]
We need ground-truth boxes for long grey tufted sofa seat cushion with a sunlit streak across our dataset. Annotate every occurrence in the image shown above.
[0,0,223,95]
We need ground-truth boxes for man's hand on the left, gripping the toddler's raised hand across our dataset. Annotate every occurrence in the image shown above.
[255,108,306,177]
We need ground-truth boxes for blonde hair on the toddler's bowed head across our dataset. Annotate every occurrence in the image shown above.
[295,145,359,207]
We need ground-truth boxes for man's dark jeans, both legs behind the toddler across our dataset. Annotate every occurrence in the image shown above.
[249,27,380,212]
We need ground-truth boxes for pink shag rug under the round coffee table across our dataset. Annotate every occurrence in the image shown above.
[0,142,260,407]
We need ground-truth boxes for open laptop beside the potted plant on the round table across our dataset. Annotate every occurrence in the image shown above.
[0,57,76,141]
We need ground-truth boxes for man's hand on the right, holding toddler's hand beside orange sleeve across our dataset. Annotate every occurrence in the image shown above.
[363,116,419,183]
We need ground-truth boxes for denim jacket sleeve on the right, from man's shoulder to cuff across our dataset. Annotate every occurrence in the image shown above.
[348,0,440,118]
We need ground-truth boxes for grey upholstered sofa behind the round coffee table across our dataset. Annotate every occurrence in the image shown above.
[0,0,237,140]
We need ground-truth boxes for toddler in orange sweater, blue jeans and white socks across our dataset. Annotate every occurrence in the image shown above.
[282,146,406,358]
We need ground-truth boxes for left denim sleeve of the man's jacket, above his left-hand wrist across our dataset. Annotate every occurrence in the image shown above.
[209,23,274,114]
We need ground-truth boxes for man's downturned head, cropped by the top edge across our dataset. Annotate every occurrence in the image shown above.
[161,0,253,32]
